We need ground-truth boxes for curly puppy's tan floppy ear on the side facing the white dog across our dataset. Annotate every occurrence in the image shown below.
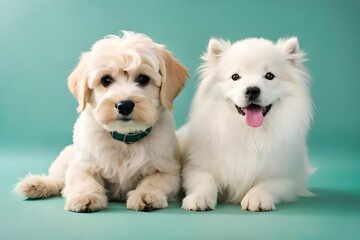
[157,45,189,110]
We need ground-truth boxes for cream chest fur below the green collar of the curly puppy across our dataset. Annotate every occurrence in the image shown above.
[72,108,174,200]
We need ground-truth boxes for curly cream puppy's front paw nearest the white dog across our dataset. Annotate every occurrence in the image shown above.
[126,190,168,212]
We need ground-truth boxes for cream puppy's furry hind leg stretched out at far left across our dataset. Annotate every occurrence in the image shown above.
[14,145,75,199]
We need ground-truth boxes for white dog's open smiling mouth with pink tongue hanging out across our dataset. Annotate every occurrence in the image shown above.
[235,103,271,128]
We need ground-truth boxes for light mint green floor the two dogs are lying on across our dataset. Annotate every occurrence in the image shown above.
[0,145,360,240]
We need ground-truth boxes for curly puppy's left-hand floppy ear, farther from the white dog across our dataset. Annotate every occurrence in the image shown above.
[68,53,90,112]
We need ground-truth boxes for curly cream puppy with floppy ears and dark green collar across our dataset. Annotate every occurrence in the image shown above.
[15,32,188,212]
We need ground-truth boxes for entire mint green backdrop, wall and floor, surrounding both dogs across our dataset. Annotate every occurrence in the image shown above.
[0,0,360,239]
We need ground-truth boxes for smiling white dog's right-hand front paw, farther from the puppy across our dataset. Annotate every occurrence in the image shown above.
[241,189,275,212]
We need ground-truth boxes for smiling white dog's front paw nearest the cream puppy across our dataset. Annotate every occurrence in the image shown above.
[182,194,216,211]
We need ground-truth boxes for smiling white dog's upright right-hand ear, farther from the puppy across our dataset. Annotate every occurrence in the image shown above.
[276,37,305,66]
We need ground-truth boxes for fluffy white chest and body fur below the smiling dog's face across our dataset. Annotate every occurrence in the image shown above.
[188,100,307,203]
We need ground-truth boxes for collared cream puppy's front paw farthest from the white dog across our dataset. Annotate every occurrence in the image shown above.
[65,193,107,212]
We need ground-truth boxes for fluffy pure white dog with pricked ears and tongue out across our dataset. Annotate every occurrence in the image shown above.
[178,37,312,211]
